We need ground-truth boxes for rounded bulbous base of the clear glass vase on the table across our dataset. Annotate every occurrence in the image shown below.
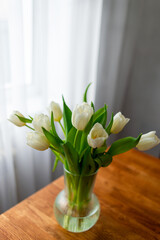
[54,190,100,233]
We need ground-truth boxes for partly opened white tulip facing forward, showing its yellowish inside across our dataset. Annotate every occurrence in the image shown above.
[87,123,108,148]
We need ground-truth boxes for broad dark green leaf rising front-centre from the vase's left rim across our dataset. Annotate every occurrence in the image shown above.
[63,142,80,173]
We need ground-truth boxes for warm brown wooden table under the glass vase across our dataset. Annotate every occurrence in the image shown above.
[0,150,160,240]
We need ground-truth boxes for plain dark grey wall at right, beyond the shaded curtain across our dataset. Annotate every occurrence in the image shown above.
[123,0,160,156]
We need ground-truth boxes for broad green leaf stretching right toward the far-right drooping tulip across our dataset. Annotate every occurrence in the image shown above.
[107,134,142,156]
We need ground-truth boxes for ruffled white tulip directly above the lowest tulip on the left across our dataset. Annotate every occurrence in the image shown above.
[32,113,51,133]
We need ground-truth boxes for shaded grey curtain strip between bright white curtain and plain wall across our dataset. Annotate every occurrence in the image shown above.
[96,0,130,115]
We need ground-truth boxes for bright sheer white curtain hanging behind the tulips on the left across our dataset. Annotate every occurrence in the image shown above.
[0,0,102,212]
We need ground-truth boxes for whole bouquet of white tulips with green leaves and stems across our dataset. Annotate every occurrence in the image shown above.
[9,84,160,232]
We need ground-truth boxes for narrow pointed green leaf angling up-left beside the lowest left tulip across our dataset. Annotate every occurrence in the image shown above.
[42,127,63,153]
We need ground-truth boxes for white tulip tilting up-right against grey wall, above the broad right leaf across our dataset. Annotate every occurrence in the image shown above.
[111,112,130,134]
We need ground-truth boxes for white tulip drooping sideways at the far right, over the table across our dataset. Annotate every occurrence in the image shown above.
[136,131,160,151]
